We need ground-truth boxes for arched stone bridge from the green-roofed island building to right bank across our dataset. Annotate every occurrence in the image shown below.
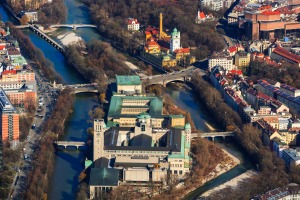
[141,66,206,87]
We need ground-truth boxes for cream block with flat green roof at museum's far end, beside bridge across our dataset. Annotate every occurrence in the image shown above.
[116,75,142,95]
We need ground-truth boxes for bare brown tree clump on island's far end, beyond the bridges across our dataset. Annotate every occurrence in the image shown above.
[65,40,130,93]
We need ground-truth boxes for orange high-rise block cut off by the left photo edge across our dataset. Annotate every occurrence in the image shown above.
[0,88,20,146]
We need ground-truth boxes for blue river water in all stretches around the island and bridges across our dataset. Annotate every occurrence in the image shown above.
[0,0,251,200]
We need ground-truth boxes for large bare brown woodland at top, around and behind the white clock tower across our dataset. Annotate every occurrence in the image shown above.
[82,0,224,59]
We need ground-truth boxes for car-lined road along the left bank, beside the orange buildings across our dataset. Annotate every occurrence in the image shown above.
[10,65,57,200]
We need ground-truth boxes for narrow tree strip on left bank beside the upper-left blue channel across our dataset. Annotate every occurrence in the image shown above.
[7,22,63,83]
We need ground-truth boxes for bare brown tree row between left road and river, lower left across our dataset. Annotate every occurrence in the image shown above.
[24,89,74,200]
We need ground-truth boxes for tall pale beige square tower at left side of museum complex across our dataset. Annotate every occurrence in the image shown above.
[93,119,106,161]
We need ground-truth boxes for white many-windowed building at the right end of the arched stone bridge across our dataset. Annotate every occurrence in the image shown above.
[208,52,235,71]
